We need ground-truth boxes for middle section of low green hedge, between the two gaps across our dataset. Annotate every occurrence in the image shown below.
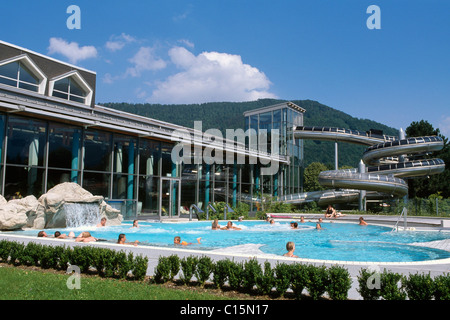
[154,255,352,300]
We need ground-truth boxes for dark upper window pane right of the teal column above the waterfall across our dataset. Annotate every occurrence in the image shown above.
[84,130,111,171]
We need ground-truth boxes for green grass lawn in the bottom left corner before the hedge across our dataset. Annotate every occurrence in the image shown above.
[0,264,237,300]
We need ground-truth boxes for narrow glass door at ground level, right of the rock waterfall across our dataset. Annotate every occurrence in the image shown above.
[159,178,180,218]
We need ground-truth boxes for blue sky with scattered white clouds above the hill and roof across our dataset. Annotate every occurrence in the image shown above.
[0,0,450,136]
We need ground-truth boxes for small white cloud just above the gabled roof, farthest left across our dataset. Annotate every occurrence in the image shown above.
[48,38,97,64]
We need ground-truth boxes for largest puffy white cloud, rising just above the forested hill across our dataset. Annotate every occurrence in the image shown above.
[149,47,276,103]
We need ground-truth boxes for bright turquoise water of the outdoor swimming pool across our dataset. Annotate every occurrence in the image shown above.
[10,221,450,262]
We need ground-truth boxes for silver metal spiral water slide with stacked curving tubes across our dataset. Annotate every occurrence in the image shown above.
[282,126,445,204]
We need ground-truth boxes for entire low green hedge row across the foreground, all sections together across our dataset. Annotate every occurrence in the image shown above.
[0,240,450,300]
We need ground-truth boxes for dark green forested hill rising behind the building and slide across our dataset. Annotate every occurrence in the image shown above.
[99,99,398,167]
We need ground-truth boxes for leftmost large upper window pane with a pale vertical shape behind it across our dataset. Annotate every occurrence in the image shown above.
[6,117,47,166]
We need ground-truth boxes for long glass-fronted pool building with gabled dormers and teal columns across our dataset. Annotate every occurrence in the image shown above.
[0,41,304,219]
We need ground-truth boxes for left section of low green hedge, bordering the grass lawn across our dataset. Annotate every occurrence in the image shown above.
[0,240,148,280]
